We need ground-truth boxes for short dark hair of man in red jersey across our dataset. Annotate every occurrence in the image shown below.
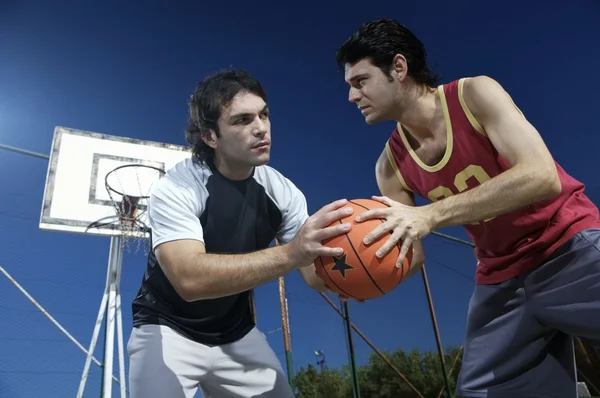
[335,18,440,87]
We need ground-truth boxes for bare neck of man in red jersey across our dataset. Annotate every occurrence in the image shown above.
[394,87,440,141]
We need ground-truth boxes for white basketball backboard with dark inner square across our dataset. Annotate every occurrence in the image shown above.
[40,127,191,236]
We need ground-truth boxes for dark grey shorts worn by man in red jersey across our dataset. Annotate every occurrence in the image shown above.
[456,229,600,398]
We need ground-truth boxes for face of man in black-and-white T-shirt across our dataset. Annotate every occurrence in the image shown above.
[211,92,271,167]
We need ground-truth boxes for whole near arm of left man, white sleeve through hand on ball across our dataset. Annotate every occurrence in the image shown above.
[148,177,346,301]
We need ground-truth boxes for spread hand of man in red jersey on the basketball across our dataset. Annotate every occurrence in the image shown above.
[355,196,434,267]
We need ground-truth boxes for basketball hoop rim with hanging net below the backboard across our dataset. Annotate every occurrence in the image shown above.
[104,164,165,254]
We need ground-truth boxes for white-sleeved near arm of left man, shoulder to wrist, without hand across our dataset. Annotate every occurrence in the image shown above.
[148,177,297,301]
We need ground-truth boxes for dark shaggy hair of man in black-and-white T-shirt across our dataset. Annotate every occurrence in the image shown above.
[185,69,267,162]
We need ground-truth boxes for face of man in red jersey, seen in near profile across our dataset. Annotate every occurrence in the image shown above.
[344,59,401,124]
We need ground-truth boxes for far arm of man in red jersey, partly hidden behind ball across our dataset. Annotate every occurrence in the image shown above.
[375,145,425,278]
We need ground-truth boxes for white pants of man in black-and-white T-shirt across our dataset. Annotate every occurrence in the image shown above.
[127,325,294,398]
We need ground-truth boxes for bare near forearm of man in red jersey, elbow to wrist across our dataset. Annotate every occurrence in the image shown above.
[426,164,561,229]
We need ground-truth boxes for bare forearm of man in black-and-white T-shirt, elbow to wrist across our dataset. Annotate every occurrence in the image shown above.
[177,246,296,301]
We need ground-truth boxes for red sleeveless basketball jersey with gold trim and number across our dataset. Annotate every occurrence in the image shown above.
[386,79,600,284]
